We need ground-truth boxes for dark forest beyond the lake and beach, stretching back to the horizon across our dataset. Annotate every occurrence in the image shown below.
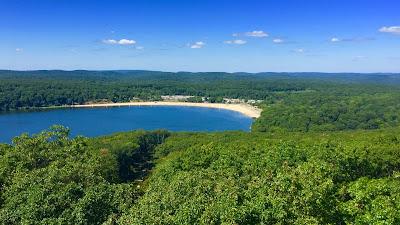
[0,70,400,111]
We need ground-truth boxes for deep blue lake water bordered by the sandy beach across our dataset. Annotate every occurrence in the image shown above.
[0,106,253,143]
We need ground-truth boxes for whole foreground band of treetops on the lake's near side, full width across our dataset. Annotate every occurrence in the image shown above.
[0,127,400,224]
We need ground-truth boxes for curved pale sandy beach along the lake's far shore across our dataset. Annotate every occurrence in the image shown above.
[70,101,262,118]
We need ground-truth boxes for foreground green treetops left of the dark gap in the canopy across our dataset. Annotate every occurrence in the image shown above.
[0,127,168,225]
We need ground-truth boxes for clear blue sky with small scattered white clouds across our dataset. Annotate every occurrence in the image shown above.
[0,0,400,72]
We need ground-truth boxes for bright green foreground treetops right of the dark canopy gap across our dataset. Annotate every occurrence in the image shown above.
[120,129,400,224]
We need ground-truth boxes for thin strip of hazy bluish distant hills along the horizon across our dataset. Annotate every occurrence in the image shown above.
[0,70,400,84]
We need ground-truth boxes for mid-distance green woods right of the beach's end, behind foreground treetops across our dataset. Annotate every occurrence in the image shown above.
[253,89,400,132]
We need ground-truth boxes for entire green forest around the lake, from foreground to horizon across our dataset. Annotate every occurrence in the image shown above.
[0,71,400,225]
